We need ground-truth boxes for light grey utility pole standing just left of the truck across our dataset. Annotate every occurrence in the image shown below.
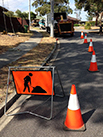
[50,0,54,37]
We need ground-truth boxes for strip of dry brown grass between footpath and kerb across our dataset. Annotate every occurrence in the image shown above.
[0,33,56,103]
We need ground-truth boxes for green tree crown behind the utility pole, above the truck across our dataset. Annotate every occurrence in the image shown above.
[32,0,73,16]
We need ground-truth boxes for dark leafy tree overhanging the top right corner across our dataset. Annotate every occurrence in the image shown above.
[75,0,103,32]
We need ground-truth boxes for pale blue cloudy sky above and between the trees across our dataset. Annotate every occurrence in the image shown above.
[0,0,87,21]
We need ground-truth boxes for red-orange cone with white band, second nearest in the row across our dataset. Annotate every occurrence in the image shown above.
[88,50,99,72]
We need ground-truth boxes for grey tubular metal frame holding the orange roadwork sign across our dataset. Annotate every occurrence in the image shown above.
[4,66,65,120]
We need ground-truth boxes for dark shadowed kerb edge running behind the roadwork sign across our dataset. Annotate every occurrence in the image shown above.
[0,39,57,117]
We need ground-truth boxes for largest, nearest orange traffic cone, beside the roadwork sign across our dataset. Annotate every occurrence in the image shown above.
[64,84,86,131]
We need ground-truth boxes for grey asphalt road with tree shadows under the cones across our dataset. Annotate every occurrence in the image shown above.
[0,32,103,137]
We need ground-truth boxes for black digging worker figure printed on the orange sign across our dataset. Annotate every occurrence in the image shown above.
[23,73,33,92]
